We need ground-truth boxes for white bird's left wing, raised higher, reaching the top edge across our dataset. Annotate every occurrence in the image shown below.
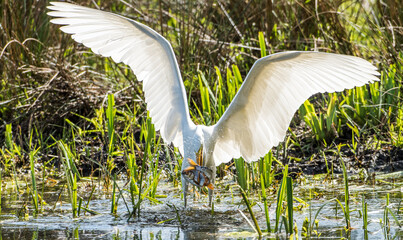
[48,2,193,154]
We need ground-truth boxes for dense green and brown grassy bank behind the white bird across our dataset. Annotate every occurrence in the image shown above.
[0,0,403,175]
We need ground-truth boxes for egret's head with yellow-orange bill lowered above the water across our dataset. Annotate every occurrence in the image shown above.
[182,147,214,190]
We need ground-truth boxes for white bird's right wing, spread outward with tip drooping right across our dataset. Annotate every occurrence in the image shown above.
[212,52,379,165]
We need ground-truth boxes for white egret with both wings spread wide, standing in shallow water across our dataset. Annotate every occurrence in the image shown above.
[48,2,379,206]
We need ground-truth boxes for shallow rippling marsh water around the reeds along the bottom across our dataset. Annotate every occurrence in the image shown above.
[0,172,403,239]
